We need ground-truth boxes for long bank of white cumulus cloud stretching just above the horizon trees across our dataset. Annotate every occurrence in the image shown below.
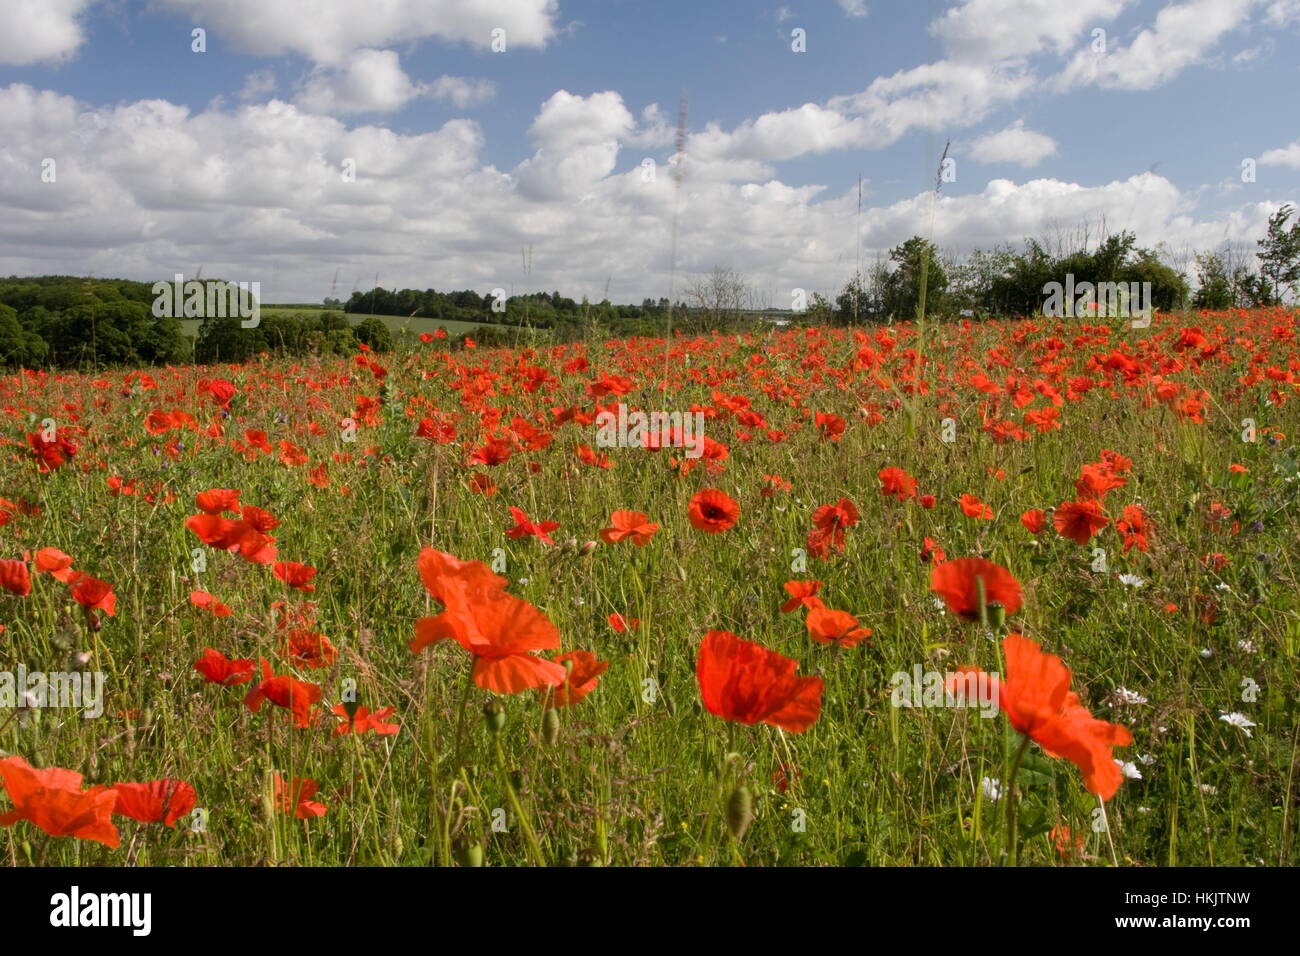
[0,85,1284,303]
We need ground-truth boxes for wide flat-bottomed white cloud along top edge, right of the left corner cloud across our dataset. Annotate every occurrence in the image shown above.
[153,0,559,65]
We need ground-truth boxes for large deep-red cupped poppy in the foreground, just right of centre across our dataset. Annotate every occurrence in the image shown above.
[696,631,823,734]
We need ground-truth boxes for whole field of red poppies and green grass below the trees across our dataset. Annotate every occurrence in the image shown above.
[0,308,1300,866]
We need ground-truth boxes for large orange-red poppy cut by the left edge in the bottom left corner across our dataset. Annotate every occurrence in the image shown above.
[0,756,121,847]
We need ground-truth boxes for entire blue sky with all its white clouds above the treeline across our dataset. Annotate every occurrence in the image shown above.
[0,0,1300,306]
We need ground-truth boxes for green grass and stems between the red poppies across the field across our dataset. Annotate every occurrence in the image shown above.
[0,312,1300,866]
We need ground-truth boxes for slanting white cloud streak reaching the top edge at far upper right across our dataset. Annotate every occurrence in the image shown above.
[1056,0,1256,90]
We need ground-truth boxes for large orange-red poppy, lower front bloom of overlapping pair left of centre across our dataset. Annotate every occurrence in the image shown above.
[411,587,564,693]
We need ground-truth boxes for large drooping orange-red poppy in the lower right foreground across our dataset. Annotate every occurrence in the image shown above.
[956,633,1132,800]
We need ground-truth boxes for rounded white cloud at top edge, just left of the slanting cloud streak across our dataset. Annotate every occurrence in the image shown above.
[930,0,1132,62]
